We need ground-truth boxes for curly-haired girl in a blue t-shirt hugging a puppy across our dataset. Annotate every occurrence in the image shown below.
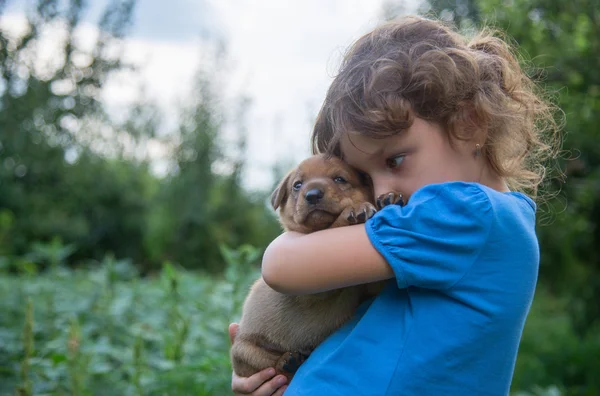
[230,13,557,396]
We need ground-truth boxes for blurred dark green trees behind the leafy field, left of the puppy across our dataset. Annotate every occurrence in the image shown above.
[0,0,280,273]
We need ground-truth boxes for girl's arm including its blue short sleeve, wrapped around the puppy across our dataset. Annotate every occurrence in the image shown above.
[262,182,496,294]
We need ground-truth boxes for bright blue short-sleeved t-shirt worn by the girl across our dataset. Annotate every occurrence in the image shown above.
[285,182,539,396]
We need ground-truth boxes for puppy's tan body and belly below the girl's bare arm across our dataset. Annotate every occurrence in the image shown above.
[231,279,365,378]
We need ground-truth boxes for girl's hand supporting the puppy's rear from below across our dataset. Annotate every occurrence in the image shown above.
[229,323,287,396]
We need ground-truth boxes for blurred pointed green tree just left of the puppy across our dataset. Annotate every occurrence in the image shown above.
[146,78,280,272]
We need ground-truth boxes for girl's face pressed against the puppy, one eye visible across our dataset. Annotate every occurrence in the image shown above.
[341,118,481,200]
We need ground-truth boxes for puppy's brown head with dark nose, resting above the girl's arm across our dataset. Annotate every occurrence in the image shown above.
[271,154,373,233]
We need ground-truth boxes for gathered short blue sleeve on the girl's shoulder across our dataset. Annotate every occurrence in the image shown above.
[366,182,493,290]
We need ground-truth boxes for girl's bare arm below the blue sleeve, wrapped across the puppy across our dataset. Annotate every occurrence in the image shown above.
[262,224,394,295]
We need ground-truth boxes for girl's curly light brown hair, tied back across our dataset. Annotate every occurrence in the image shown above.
[312,17,560,198]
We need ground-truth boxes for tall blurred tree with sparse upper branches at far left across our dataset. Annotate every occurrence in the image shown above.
[0,0,158,266]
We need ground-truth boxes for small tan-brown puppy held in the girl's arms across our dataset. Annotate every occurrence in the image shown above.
[231,155,401,379]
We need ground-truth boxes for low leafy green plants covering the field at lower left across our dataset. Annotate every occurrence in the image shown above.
[0,245,261,395]
